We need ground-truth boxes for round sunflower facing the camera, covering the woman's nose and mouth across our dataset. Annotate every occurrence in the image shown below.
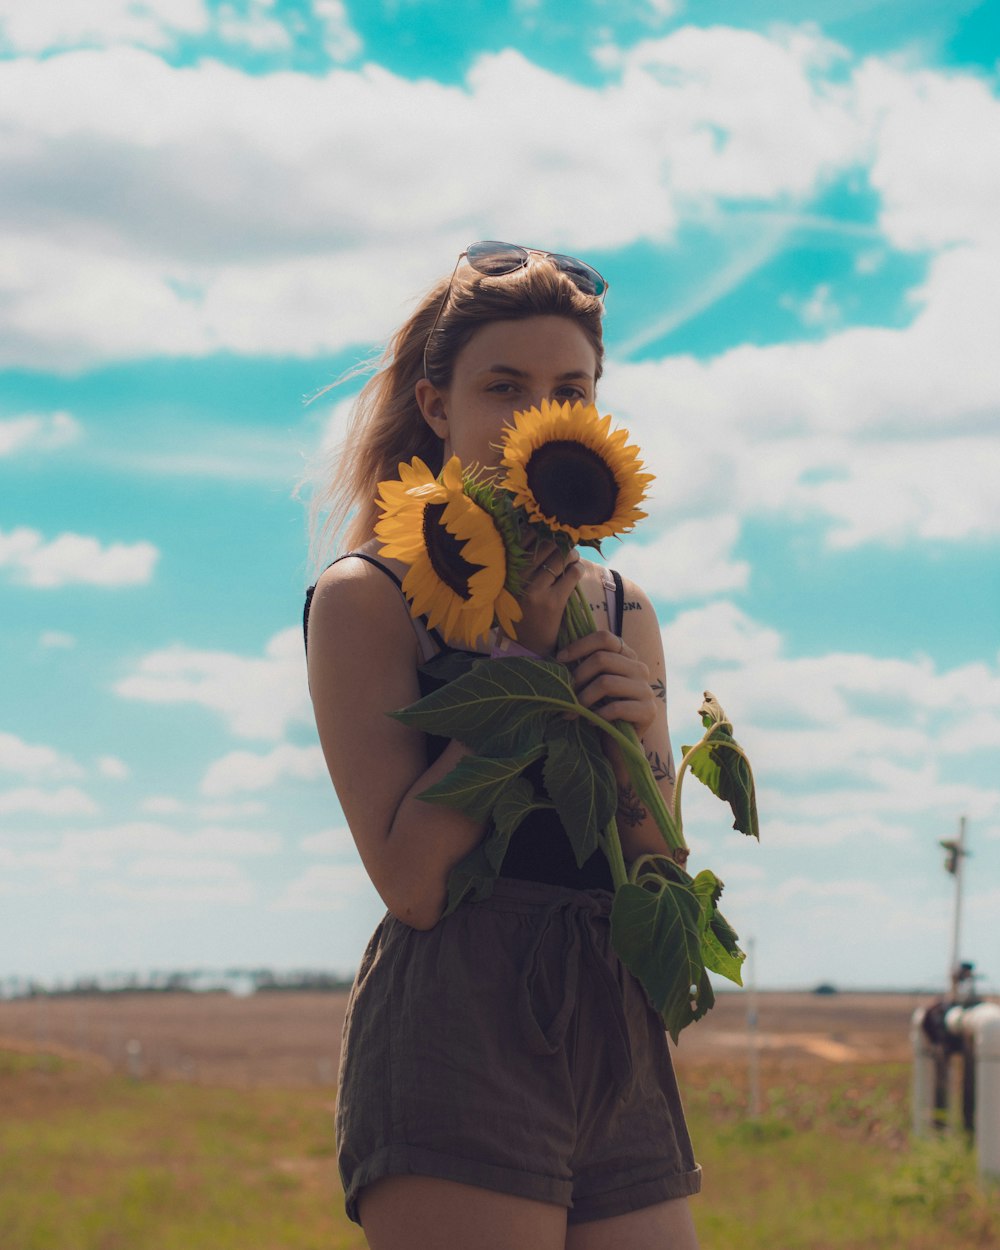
[501,400,653,544]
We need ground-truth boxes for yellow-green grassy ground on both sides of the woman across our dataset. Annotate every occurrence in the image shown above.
[0,1051,1000,1250]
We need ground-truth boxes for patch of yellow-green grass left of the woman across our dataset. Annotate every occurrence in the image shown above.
[0,1055,365,1250]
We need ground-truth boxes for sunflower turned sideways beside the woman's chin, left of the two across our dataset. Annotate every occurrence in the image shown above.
[375,456,521,646]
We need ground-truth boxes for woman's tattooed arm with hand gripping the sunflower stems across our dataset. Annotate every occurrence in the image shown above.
[556,579,675,861]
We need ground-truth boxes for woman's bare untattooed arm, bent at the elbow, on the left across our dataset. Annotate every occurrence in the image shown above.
[309,560,484,929]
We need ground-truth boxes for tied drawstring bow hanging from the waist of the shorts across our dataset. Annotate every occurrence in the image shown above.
[518,891,633,1096]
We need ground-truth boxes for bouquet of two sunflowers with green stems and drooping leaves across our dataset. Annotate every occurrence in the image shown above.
[375,401,759,1041]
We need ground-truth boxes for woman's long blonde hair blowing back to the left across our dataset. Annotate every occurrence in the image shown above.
[310,261,604,568]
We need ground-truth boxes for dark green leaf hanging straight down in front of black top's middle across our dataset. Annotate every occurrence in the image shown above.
[543,719,618,866]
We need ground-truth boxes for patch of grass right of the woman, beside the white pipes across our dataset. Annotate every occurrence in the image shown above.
[683,1064,1000,1250]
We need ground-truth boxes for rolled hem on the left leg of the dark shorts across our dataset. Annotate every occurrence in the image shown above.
[344,1145,573,1224]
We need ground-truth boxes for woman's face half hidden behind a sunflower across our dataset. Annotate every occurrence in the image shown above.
[416,316,598,469]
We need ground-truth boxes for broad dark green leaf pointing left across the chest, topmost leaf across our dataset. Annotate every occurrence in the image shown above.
[393,656,580,756]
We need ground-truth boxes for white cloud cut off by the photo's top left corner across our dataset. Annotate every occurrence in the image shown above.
[0,0,209,54]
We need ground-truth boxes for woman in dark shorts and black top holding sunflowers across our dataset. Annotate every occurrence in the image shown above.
[306,243,700,1250]
